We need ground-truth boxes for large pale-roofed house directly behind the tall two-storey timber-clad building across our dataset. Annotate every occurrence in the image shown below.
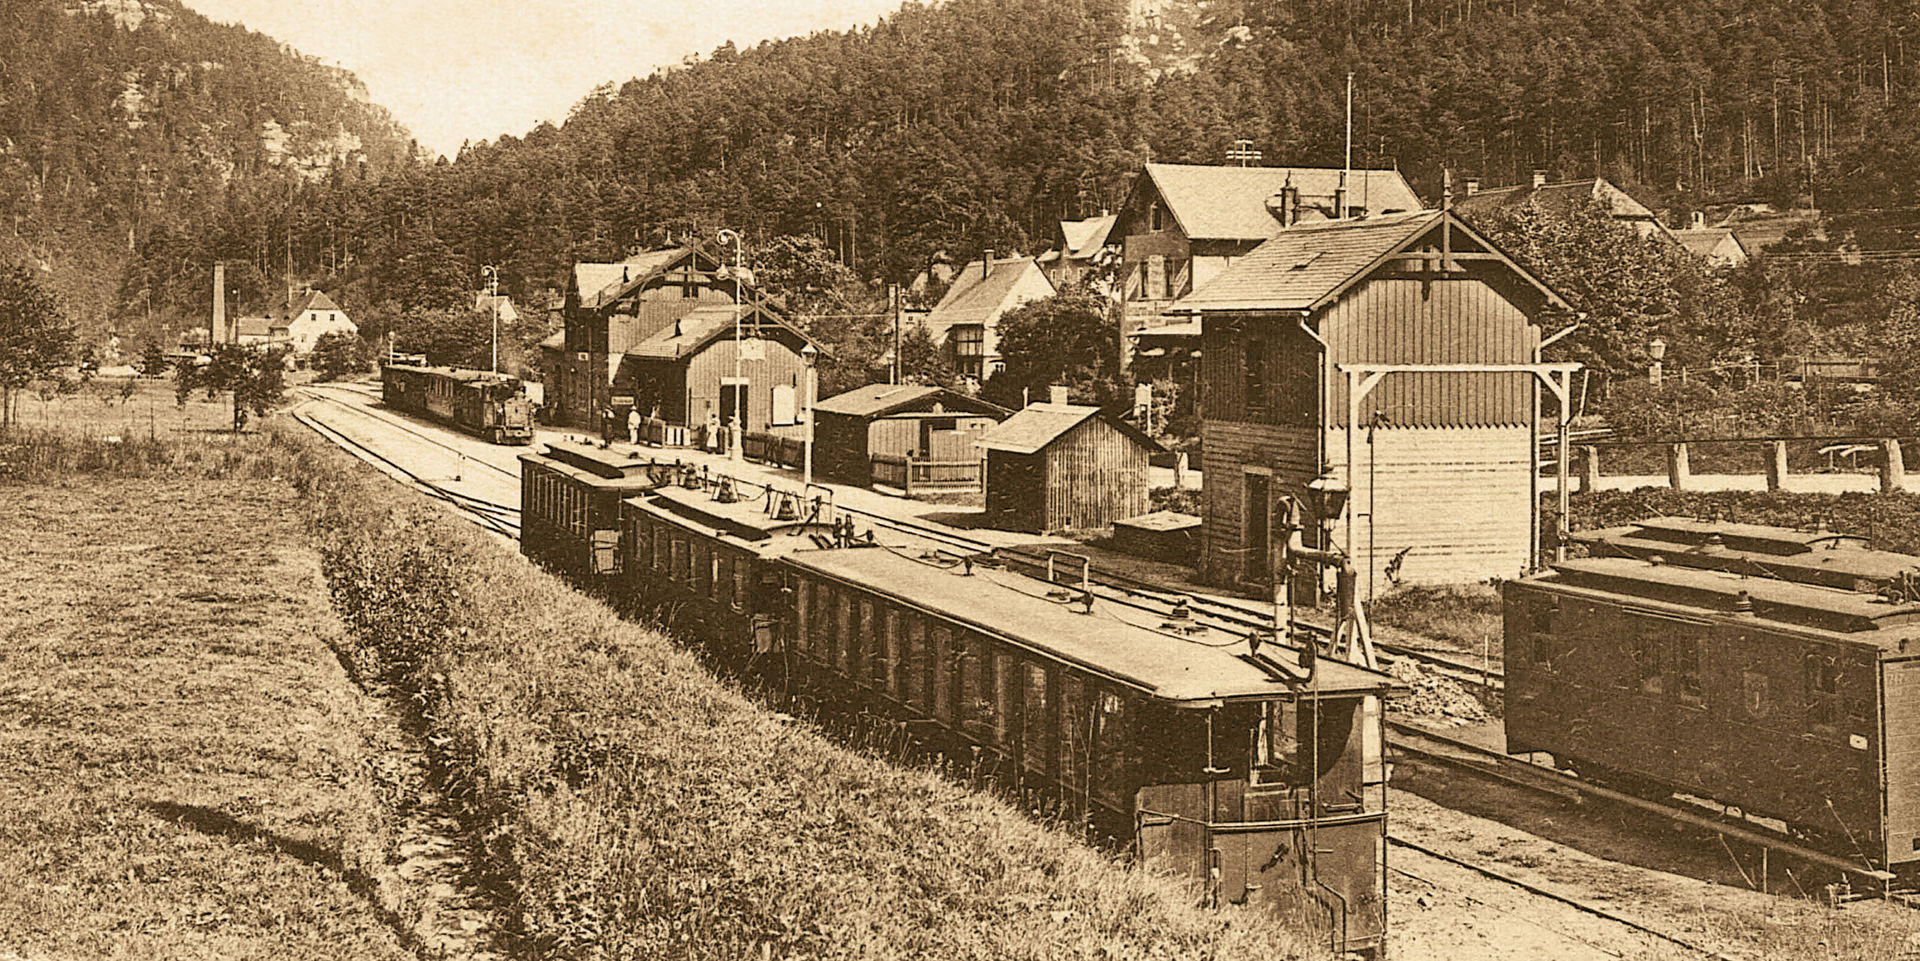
[1106,163,1425,349]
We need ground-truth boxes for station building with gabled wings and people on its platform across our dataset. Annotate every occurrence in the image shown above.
[541,247,818,443]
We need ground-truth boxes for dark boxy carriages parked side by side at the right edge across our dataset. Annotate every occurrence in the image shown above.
[1503,518,1920,886]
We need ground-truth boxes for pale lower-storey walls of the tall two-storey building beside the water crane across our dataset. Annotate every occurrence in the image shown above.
[1200,420,1532,597]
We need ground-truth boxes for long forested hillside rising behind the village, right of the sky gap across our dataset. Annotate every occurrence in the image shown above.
[228,0,1920,314]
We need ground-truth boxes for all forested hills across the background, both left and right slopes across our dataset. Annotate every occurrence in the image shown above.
[30,0,1920,362]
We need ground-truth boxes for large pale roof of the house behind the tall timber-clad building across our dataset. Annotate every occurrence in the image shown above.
[1121,163,1425,240]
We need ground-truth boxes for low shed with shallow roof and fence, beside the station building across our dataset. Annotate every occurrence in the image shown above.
[814,384,1008,485]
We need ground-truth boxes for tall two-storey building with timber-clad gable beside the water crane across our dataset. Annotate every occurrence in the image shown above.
[1175,211,1572,595]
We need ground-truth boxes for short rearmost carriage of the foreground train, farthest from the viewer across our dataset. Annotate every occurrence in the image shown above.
[520,441,655,581]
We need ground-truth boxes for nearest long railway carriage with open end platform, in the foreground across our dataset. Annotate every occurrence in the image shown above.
[780,547,1390,951]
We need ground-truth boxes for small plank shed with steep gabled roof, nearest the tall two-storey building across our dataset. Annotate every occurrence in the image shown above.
[979,403,1160,533]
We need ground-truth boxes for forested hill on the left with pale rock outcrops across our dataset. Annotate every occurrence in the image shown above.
[0,0,415,338]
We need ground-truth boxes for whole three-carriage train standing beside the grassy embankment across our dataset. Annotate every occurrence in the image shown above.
[520,443,1396,955]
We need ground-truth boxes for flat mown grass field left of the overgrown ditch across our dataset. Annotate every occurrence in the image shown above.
[0,476,411,961]
